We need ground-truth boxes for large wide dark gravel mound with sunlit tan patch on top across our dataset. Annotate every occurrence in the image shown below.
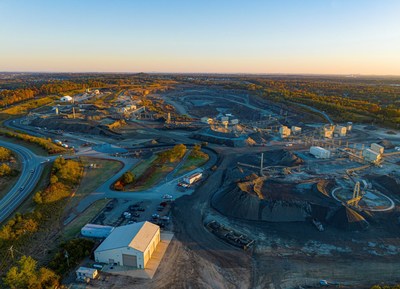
[212,175,337,222]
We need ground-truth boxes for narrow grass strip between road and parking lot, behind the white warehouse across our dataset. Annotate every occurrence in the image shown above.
[62,199,110,240]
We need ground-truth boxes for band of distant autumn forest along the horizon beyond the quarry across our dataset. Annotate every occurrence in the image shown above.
[0,73,400,128]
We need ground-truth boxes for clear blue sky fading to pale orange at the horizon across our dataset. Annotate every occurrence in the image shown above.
[0,0,400,75]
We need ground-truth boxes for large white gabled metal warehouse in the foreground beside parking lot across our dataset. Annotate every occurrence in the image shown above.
[94,221,160,269]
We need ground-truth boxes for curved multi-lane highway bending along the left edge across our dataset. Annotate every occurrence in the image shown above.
[0,140,48,223]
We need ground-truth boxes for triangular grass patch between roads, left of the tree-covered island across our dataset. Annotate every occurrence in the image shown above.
[65,157,123,211]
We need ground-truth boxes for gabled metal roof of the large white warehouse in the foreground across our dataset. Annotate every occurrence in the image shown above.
[96,221,160,252]
